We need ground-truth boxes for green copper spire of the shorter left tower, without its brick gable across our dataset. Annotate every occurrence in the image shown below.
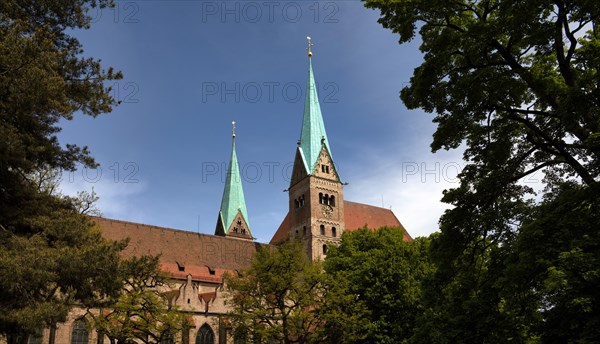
[219,122,252,237]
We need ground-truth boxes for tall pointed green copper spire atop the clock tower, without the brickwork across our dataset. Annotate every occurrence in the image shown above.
[300,56,331,174]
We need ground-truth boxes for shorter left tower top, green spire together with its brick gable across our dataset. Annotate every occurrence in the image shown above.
[215,122,254,240]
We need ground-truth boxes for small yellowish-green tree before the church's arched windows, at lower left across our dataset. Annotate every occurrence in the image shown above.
[88,256,190,344]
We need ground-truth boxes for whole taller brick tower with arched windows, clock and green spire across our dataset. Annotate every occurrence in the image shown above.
[289,37,344,259]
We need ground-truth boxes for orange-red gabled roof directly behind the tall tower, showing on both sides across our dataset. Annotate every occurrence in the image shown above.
[270,201,412,245]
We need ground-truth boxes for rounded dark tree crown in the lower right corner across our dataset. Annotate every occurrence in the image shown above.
[500,183,600,343]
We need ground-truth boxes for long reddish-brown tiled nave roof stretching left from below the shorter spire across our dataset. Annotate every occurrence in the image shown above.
[93,217,264,283]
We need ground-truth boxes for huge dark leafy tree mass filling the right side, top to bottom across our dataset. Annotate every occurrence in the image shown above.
[366,0,600,343]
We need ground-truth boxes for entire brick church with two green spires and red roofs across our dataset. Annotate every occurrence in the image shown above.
[18,39,411,344]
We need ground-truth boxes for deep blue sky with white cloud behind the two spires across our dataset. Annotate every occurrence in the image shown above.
[59,1,463,242]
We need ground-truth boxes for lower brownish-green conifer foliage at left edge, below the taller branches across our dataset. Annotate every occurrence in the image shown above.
[0,179,126,343]
